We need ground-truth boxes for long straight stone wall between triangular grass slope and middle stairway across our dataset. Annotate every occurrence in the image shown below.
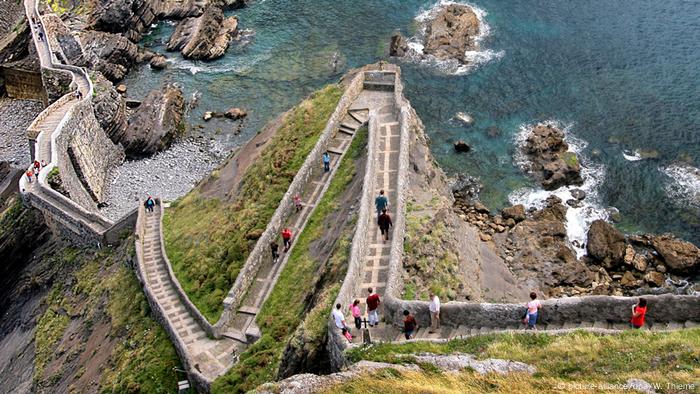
[215,73,364,334]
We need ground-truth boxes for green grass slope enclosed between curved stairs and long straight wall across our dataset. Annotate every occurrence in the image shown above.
[163,85,343,322]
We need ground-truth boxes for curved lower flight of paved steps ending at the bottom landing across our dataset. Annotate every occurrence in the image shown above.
[143,207,245,380]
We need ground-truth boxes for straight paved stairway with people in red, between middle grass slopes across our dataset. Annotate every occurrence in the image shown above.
[224,108,368,340]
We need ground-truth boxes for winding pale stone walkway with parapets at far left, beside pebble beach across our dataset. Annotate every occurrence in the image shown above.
[19,0,114,240]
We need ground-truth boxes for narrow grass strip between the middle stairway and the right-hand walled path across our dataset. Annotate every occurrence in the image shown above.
[212,127,367,393]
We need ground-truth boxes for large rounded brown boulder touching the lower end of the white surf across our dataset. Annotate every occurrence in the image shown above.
[586,220,626,268]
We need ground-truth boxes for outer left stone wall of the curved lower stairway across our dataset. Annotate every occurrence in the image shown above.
[134,204,212,392]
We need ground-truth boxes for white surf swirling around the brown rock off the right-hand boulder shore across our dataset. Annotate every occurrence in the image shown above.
[508,120,609,258]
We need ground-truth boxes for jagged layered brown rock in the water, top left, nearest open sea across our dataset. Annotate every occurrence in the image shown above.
[166,6,238,60]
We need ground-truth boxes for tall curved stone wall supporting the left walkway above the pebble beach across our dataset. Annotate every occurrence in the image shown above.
[57,100,124,206]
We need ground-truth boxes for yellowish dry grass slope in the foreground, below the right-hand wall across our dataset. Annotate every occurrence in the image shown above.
[336,329,700,393]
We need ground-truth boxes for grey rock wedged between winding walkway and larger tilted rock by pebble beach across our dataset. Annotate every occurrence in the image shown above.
[92,72,127,144]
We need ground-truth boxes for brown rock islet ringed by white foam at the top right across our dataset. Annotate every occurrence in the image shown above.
[423,4,479,62]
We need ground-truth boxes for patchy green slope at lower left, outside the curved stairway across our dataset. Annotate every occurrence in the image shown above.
[34,241,180,393]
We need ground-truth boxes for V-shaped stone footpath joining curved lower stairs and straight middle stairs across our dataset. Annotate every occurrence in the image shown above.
[136,72,367,390]
